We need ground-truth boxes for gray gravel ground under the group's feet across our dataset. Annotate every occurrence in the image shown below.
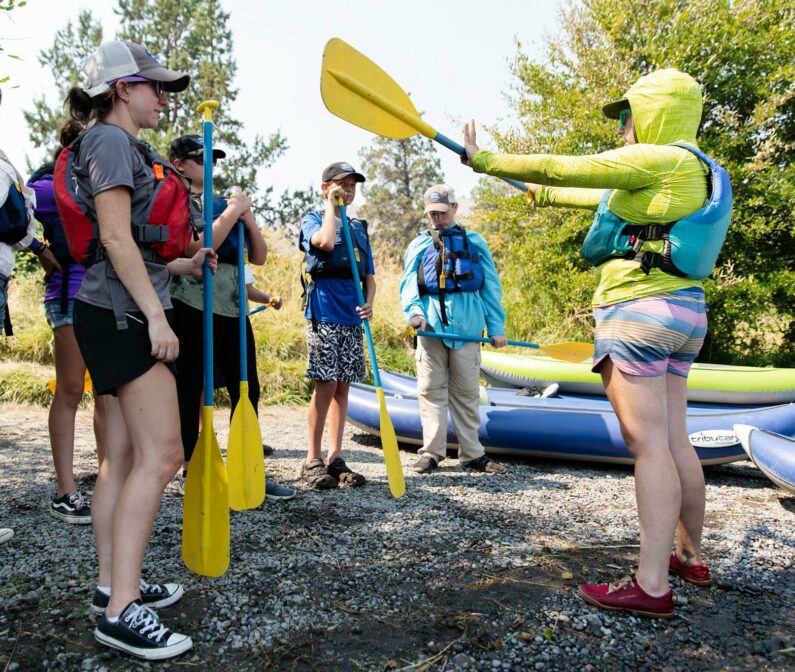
[0,405,795,672]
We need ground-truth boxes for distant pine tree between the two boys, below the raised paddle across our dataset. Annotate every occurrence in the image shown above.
[358,136,444,257]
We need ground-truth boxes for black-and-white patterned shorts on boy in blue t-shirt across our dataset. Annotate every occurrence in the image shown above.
[306,322,365,383]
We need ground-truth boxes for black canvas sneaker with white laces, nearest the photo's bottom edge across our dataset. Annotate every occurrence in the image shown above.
[94,602,193,660]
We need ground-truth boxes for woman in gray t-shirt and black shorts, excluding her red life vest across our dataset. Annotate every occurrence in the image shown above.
[58,41,215,659]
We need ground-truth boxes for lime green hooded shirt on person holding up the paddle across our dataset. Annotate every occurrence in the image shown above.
[472,69,708,306]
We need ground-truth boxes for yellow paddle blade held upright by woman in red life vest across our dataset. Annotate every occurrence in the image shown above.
[182,406,229,576]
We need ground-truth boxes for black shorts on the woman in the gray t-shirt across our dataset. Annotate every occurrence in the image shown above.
[74,299,175,396]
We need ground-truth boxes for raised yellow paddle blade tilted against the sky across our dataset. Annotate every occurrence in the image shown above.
[320,37,436,138]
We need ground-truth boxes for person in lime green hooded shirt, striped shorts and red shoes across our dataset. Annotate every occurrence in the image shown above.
[464,69,731,618]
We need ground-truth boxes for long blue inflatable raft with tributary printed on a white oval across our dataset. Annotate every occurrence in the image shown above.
[348,372,795,465]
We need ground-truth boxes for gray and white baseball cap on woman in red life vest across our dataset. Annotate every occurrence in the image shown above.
[82,40,190,98]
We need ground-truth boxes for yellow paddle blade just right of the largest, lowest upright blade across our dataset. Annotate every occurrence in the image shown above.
[226,381,265,511]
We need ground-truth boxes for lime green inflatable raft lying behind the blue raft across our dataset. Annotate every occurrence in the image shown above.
[480,350,795,405]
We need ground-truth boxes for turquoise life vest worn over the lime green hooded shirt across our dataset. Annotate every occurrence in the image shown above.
[582,142,732,280]
